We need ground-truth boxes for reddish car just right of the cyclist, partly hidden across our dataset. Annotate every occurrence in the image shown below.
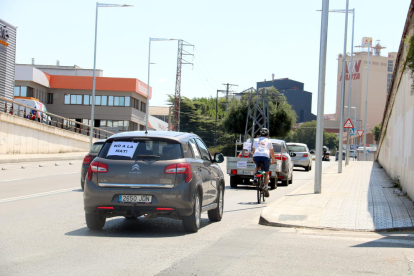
[270,139,296,186]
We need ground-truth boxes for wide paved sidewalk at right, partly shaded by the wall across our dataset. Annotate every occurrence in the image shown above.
[259,161,414,231]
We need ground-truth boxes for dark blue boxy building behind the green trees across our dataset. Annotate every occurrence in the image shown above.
[257,78,316,123]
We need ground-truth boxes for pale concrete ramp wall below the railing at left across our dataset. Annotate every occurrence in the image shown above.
[0,113,89,154]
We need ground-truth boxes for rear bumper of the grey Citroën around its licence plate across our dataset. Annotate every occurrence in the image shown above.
[83,180,195,217]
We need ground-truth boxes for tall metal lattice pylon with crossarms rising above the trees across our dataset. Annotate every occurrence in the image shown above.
[173,39,194,131]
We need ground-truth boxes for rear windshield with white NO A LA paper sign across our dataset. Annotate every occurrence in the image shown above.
[99,138,183,160]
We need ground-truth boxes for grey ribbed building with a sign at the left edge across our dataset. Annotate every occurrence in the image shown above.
[0,19,16,100]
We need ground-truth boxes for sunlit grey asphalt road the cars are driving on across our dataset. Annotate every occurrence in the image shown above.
[0,158,414,275]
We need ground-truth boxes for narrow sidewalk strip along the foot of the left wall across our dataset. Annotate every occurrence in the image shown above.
[0,152,88,164]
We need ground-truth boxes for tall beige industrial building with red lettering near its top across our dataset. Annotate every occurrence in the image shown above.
[335,43,397,145]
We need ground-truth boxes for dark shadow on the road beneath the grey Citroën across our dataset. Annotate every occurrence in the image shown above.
[65,217,212,238]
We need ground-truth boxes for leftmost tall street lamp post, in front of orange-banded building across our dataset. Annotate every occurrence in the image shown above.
[89,2,133,148]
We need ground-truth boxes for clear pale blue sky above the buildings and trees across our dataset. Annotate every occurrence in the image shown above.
[0,0,410,114]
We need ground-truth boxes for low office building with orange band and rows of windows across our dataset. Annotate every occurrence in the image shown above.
[14,64,168,134]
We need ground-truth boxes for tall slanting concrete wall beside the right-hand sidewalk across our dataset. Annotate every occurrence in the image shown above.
[377,7,414,199]
